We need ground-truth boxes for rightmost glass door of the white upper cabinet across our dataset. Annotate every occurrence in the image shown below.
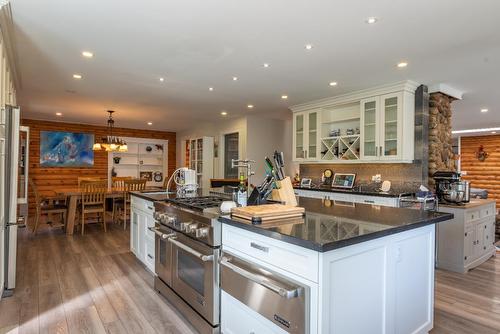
[379,93,402,160]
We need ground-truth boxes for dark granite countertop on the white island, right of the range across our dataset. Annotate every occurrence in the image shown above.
[219,197,453,252]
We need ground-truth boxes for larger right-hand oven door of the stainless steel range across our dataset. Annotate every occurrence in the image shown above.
[168,234,220,324]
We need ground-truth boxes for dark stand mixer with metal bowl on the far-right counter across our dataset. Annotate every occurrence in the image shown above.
[433,171,470,205]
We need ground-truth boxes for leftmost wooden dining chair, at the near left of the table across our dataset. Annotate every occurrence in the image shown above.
[28,178,68,234]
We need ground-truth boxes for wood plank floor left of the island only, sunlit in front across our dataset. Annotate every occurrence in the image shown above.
[0,220,194,334]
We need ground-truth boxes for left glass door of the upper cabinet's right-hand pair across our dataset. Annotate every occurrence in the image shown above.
[360,97,380,160]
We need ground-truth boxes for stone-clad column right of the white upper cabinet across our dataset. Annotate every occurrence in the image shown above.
[429,92,456,185]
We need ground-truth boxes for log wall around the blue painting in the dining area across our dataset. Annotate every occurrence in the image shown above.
[21,119,176,211]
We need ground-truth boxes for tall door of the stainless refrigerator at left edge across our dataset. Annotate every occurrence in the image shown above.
[1,106,19,290]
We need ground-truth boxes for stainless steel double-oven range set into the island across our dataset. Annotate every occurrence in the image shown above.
[153,196,224,333]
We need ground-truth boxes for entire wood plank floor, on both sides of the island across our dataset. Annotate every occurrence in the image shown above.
[0,220,500,334]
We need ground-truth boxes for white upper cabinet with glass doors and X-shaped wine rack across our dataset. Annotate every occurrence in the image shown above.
[291,81,418,163]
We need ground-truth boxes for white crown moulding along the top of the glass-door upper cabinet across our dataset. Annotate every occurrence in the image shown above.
[290,80,419,112]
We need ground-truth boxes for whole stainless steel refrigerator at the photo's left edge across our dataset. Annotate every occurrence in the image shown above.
[0,106,27,296]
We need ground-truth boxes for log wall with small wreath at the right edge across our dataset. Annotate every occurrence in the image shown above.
[460,135,500,209]
